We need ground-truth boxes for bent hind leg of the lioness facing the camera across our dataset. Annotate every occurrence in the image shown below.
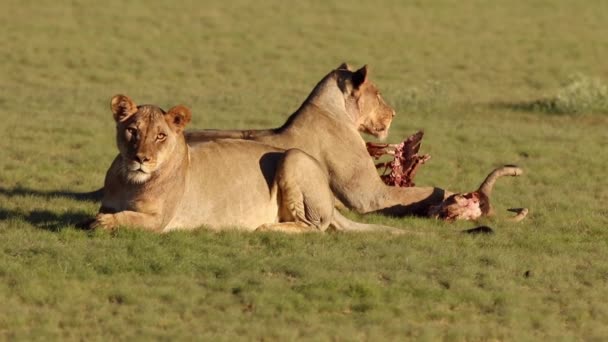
[276,149,334,231]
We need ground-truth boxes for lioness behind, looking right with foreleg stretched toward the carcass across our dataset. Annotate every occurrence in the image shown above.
[186,64,521,219]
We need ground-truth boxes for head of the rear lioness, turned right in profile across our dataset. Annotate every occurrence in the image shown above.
[335,63,395,139]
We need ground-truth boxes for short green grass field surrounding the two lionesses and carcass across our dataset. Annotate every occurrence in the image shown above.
[0,0,608,341]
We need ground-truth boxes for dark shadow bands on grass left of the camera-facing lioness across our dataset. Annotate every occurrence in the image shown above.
[0,187,103,232]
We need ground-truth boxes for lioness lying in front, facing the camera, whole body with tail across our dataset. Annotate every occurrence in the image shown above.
[91,95,403,232]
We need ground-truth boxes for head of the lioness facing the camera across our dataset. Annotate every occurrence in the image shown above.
[111,95,192,184]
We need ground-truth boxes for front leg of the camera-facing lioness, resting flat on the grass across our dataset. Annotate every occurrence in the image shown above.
[90,211,161,232]
